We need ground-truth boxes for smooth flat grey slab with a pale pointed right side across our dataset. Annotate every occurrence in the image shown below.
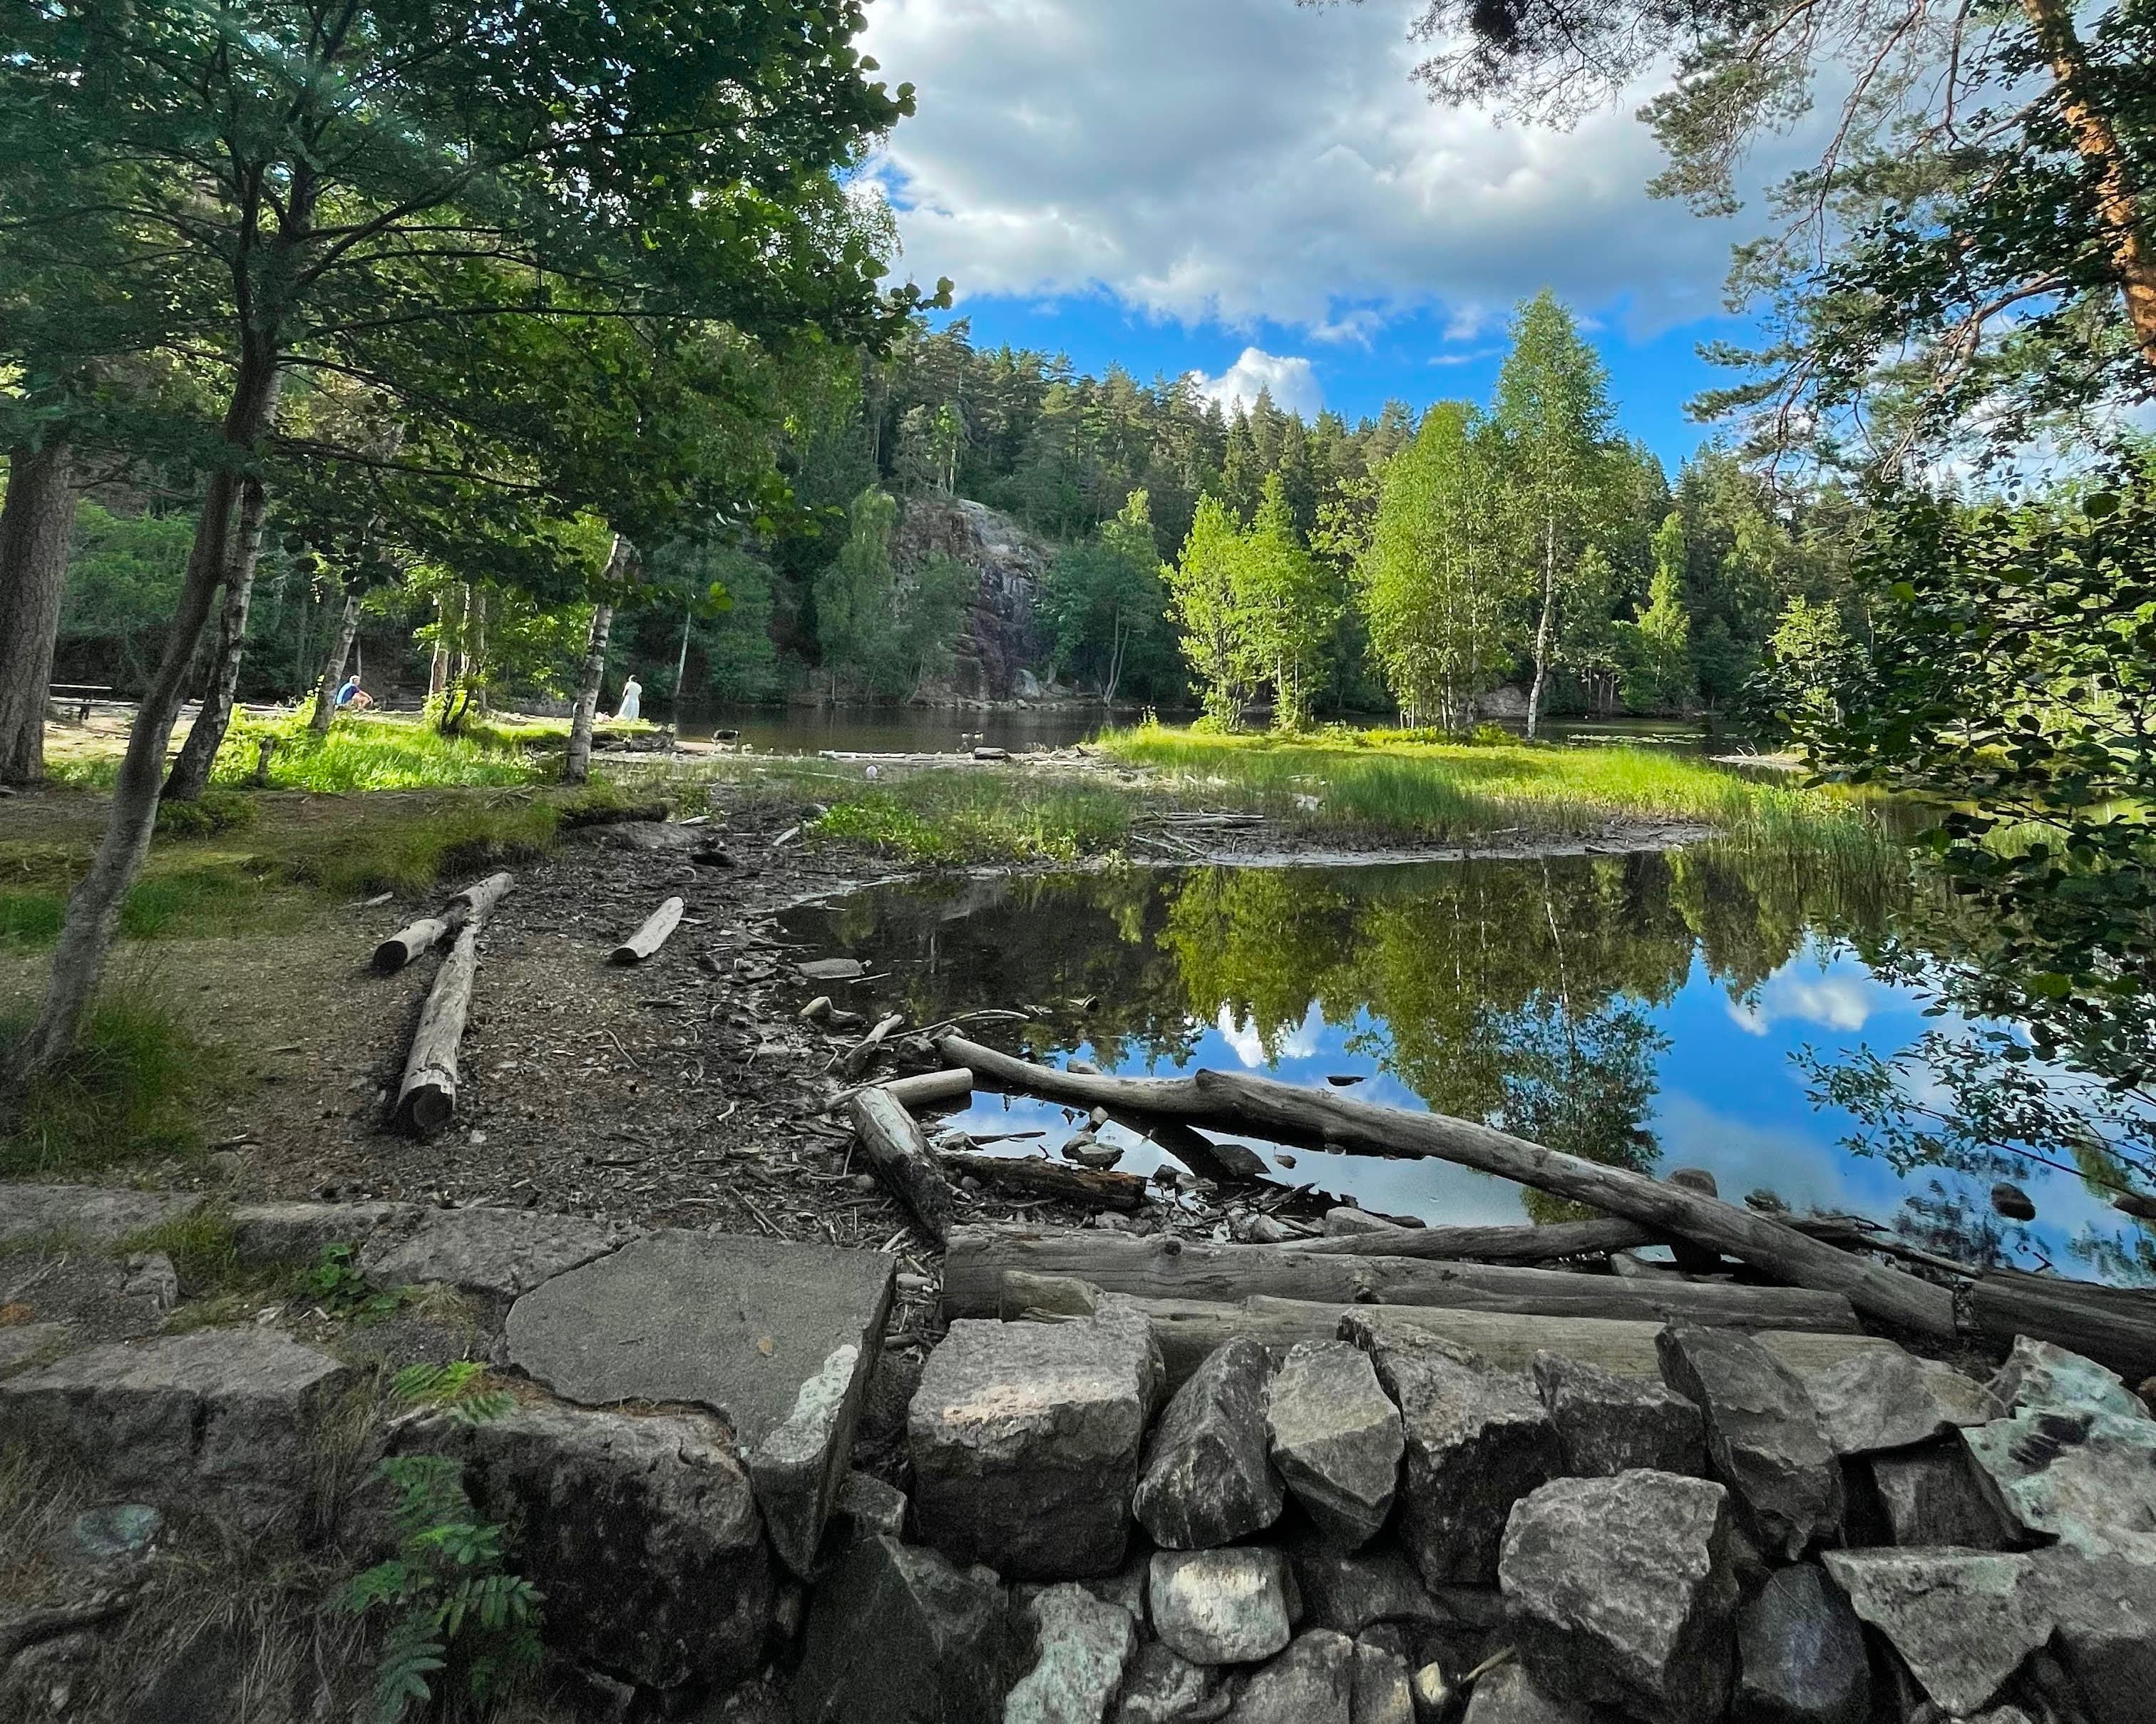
[509,1231,893,1577]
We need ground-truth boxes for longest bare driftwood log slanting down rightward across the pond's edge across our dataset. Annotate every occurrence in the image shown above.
[938,1037,1956,1338]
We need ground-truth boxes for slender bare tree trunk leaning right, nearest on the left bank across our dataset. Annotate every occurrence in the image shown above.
[17,347,278,1075]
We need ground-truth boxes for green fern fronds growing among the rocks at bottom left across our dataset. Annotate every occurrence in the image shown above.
[343,1362,543,1724]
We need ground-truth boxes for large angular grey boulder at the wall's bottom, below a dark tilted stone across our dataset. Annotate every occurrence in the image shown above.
[1499,1472,1737,1724]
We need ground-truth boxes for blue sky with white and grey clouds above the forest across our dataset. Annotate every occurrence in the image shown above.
[867,0,1807,466]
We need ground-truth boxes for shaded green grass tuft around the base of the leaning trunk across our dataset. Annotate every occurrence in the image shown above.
[0,991,231,1174]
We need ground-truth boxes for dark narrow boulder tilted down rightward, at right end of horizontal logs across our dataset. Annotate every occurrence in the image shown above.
[1655,1323,1841,1560]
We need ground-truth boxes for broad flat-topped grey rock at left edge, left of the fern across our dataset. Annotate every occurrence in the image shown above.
[0,1328,351,1528]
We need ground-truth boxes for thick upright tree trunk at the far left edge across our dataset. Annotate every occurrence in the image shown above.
[0,442,76,784]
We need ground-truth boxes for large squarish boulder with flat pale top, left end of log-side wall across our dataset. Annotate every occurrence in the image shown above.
[905,1315,1160,1579]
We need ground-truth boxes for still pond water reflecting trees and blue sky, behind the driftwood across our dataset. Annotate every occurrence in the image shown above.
[787,841,2118,1273]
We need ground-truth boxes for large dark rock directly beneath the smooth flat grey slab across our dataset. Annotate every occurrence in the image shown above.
[419,1403,772,1688]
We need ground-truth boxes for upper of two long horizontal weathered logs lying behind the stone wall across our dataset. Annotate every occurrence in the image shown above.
[942,1226,1857,1330]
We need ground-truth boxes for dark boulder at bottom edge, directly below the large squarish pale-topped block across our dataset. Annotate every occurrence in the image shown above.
[794,1534,1007,1724]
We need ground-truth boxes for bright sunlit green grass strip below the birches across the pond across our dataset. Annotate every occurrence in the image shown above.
[1097,724,1867,843]
